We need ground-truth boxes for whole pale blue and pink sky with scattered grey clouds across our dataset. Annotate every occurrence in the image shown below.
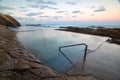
[0,0,120,25]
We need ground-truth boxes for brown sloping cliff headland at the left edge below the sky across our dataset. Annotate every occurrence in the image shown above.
[0,13,20,27]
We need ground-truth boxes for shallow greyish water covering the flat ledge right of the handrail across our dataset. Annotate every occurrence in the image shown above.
[67,43,120,80]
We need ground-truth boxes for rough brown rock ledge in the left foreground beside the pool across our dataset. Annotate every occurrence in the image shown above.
[0,25,98,80]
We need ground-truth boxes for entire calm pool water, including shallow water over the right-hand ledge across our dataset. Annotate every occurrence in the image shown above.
[17,28,120,80]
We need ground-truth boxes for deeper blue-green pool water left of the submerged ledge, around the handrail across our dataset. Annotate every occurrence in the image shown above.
[16,26,108,72]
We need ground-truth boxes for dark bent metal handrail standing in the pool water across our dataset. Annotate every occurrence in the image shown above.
[59,43,88,64]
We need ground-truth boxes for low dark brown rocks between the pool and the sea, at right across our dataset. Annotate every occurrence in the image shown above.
[56,26,120,45]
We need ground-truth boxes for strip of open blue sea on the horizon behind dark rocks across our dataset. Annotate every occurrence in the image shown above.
[21,22,120,28]
